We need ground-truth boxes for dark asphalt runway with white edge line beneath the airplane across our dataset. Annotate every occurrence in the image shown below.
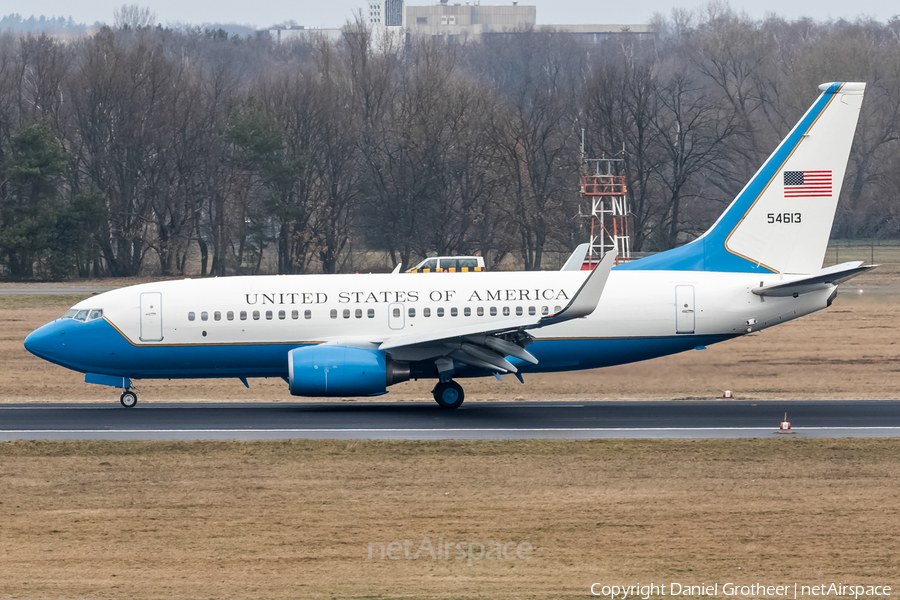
[0,400,900,441]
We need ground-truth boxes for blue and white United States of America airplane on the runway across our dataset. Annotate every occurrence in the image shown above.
[25,82,876,409]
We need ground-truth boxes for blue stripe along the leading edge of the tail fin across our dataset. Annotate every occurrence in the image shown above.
[615,83,841,273]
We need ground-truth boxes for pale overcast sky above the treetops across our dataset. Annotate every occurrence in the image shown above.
[0,0,900,28]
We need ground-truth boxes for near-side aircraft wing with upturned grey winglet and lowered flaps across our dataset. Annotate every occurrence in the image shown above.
[378,254,615,373]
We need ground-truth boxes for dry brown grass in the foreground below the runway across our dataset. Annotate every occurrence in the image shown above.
[0,439,900,598]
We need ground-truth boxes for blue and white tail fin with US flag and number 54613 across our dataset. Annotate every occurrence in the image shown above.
[618,83,866,274]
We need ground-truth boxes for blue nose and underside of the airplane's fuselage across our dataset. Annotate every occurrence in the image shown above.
[25,319,733,379]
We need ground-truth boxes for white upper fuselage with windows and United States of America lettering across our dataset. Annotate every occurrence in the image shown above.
[74,269,833,358]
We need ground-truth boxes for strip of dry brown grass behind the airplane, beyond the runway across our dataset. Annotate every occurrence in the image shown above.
[0,270,900,402]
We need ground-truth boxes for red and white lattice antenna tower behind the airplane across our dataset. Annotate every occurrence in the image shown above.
[581,137,631,270]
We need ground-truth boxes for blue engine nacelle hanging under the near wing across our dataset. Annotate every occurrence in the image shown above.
[288,344,409,398]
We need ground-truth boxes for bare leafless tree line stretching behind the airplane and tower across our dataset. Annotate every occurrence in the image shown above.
[0,5,900,279]
